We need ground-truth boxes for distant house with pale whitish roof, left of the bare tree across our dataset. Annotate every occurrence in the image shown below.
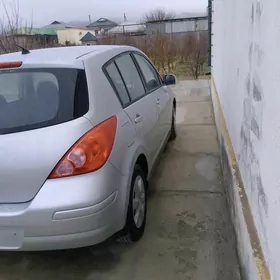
[108,21,146,36]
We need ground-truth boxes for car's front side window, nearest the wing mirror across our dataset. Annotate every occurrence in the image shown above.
[134,54,161,92]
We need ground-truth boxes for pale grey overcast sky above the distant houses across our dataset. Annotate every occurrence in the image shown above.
[0,0,208,26]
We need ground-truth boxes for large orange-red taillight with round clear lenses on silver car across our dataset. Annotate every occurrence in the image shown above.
[49,116,117,179]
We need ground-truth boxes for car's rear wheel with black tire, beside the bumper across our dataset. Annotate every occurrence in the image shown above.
[117,164,148,244]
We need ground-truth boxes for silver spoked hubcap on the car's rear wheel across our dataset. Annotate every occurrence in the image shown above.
[133,176,146,228]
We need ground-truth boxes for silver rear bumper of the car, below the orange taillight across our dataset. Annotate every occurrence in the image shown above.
[0,163,127,251]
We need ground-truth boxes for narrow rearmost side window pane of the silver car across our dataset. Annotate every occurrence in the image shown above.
[106,62,130,105]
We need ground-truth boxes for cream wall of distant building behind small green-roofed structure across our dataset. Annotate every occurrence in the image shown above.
[57,28,94,45]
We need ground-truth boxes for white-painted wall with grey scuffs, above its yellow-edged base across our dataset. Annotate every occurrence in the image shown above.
[212,0,280,279]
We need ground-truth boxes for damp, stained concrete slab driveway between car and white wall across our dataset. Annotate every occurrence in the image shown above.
[0,80,240,280]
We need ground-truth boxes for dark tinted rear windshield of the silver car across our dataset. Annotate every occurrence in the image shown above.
[0,68,89,134]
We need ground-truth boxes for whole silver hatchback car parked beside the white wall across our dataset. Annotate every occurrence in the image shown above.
[0,46,176,251]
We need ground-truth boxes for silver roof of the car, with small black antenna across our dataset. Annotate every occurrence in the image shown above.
[0,45,137,66]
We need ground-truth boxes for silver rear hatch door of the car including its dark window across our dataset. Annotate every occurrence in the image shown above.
[0,65,92,203]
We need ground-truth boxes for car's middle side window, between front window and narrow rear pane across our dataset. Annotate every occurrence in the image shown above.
[115,54,145,101]
